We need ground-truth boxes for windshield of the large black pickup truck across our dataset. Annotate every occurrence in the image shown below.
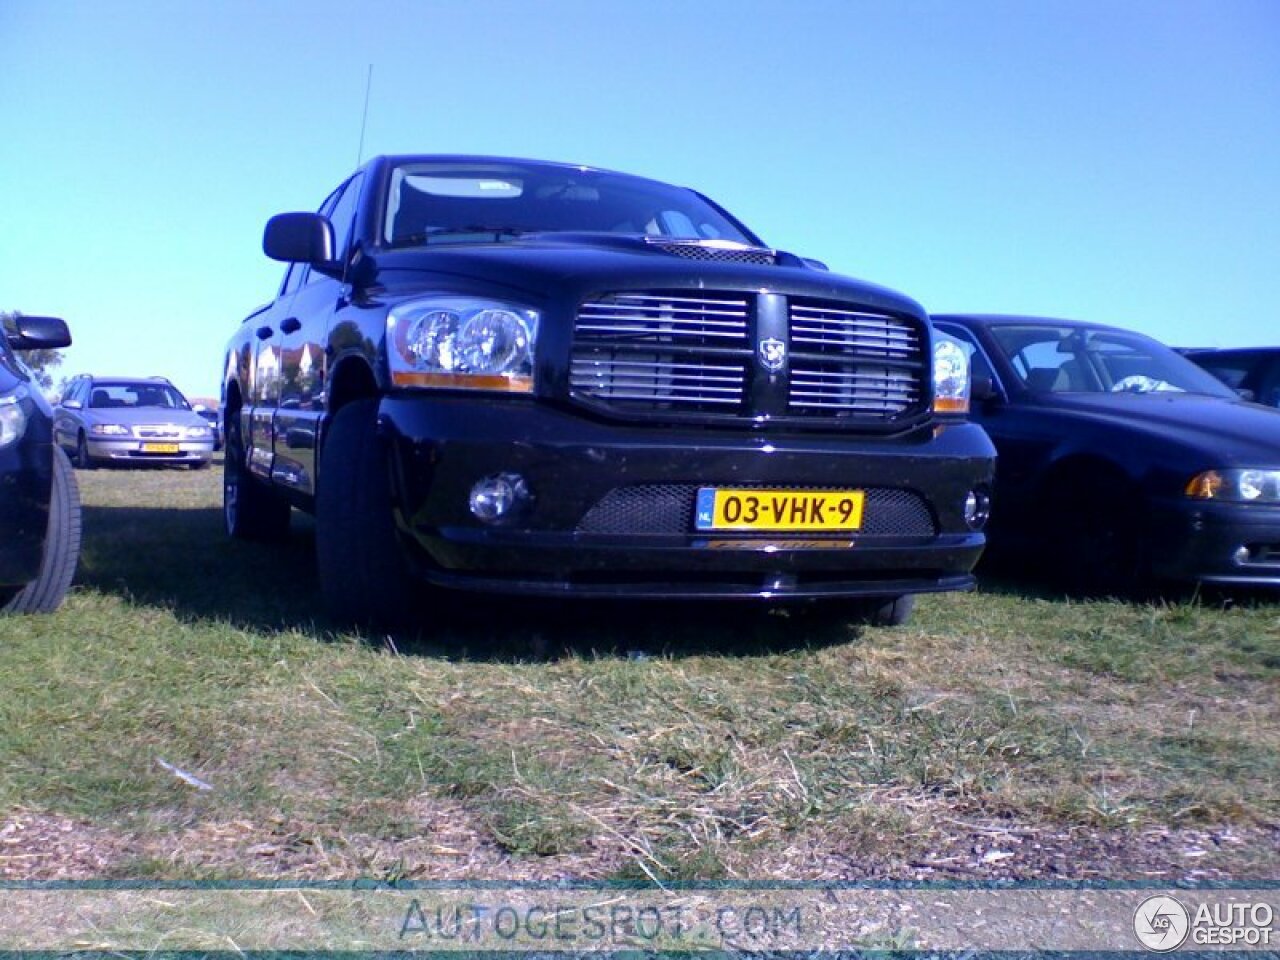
[381,163,755,247]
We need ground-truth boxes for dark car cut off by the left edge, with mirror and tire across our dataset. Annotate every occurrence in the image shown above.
[0,316,81,613]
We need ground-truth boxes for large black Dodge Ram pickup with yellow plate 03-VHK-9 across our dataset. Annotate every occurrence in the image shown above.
[223,156,993,621]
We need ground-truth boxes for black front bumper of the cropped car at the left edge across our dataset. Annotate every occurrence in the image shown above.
[0,432,54,589]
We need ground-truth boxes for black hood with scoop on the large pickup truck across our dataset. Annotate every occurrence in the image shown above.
[366,234,923,315]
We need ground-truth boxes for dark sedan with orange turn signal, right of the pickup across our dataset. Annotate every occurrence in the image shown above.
[933,315,1280,590]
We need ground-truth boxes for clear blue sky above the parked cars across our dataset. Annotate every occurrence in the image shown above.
[0,0,1280,396]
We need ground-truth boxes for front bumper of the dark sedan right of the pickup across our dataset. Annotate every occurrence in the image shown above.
[1149,498,1280,588]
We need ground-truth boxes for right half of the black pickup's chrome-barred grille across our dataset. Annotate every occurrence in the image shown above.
[787,300,925,420]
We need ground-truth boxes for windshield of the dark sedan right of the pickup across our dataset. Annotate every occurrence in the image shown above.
[991,324,1235,398]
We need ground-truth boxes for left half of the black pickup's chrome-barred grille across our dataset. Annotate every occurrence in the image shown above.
[570,292,750,412]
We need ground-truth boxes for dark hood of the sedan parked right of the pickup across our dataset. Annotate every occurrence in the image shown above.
[1038,392,1280,466]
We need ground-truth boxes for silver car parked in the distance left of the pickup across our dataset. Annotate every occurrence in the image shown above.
[54,374,214,470]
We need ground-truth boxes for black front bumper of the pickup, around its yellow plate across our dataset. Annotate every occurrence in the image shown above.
[379,394,995,600]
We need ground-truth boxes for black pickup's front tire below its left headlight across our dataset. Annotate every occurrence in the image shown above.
[316,399,412,628]
